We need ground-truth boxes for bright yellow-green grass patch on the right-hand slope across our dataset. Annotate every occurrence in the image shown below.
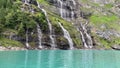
[90,15,120,31]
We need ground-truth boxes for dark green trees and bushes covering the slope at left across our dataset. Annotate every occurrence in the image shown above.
[0,0,48,46]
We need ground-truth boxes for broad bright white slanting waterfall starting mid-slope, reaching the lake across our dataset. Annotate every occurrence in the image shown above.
[58,22,74,49]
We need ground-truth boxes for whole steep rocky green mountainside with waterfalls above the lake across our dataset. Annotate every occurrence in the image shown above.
[0,0,120,49]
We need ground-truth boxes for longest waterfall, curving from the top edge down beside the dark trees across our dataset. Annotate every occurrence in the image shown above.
[37,2,56,48]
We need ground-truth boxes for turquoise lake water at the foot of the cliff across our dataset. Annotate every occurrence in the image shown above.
[0,50,120,68]
